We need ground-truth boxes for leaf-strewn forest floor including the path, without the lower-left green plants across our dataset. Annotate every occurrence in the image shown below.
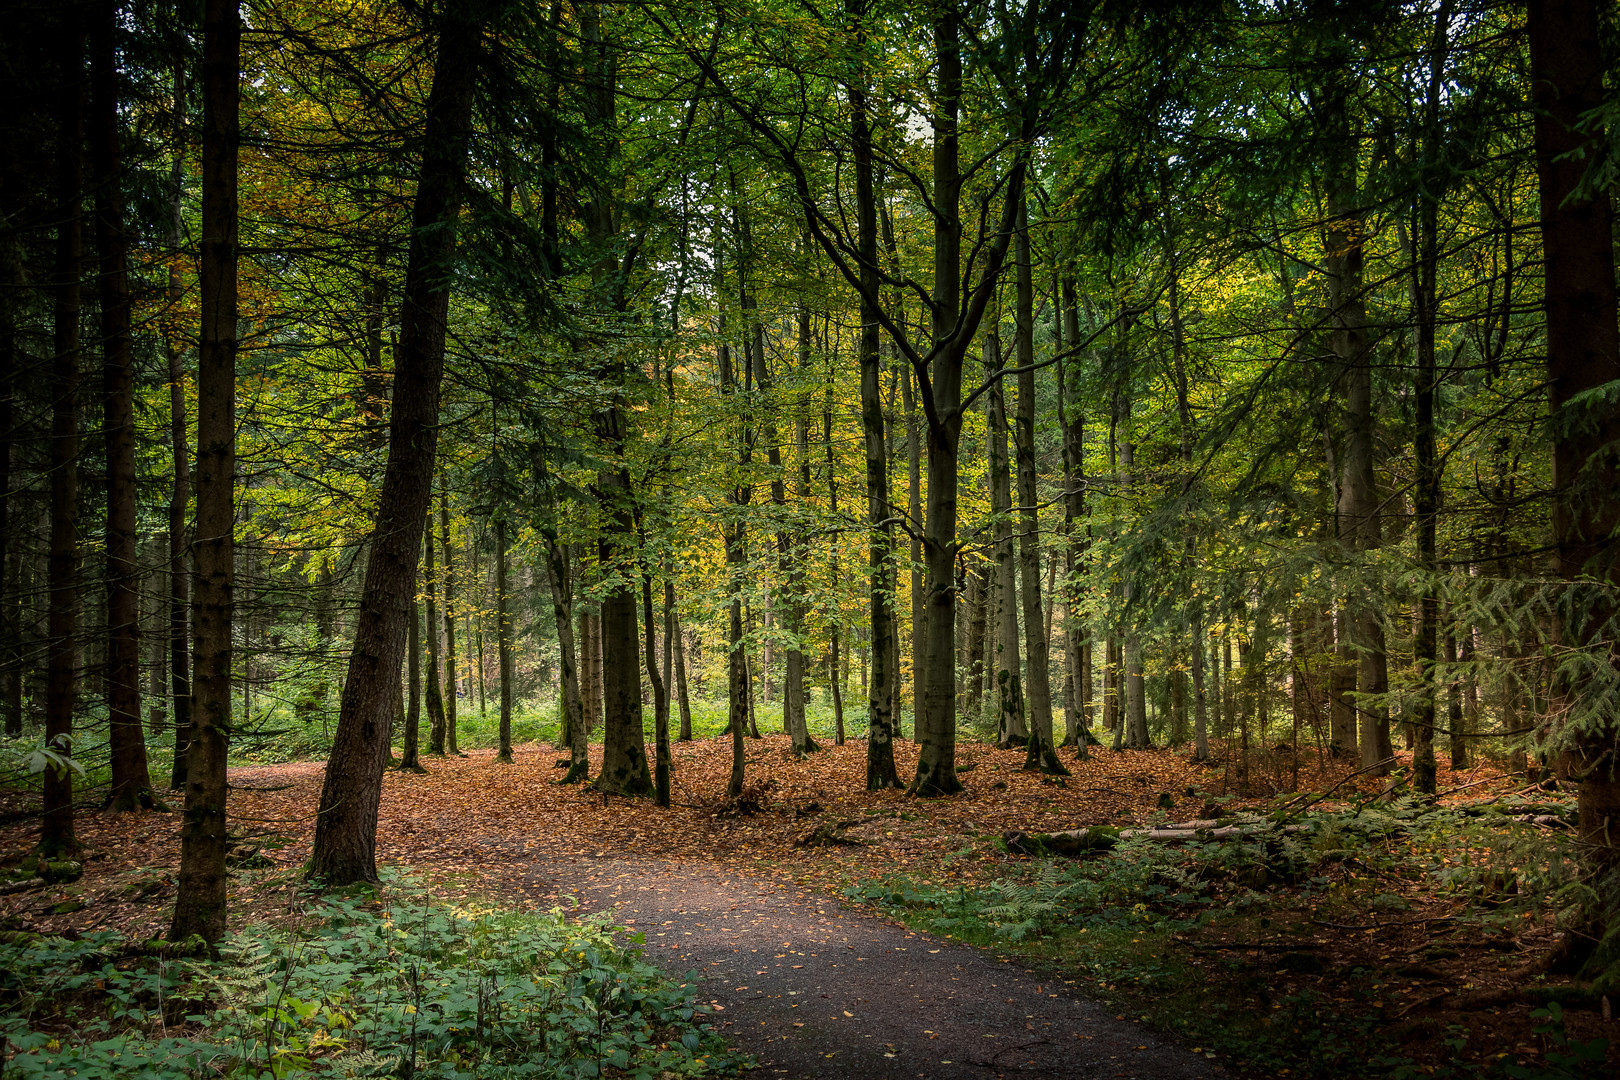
[0,735,1620,1080]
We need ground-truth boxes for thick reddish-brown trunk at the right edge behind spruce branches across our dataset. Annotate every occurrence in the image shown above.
[1528,0,1620,880]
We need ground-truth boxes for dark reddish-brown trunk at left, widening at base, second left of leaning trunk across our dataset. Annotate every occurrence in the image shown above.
[89,0,152,811]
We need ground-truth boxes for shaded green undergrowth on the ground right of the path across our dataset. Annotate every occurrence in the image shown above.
[846,798,1607,1080]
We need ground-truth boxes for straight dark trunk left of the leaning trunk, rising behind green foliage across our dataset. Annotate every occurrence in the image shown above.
[168,0,236,942]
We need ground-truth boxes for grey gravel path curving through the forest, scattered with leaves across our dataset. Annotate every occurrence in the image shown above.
[515,850,1226,1080]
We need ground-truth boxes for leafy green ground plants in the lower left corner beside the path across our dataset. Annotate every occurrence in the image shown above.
[0,889,735,1080]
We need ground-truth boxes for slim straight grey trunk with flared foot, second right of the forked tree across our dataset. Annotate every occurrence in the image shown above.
[1013,202,1069,776]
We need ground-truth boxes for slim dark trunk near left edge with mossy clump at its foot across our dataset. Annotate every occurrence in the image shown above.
[39,5,84,855]
